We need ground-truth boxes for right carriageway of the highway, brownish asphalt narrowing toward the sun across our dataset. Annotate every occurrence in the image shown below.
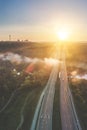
[60,50,82,130]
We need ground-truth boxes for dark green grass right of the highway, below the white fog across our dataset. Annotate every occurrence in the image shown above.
[70,80,87,130]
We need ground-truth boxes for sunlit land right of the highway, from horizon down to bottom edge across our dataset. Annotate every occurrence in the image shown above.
[66,43,87,130]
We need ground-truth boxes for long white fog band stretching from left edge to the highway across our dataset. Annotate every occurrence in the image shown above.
[0,52,59,65]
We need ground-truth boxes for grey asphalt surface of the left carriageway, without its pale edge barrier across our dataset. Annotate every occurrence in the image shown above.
[36,64,58,130]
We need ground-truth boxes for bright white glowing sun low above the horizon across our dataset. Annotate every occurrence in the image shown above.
[57,29,69,40]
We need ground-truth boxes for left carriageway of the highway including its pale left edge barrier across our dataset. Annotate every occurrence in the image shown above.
[30,45,59,130]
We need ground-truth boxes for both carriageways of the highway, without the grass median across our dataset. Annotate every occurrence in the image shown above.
[31,45,82,130]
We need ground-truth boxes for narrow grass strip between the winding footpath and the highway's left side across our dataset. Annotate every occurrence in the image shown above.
[20,88,42,130]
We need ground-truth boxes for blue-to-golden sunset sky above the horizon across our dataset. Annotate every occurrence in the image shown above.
[0,0,87,41]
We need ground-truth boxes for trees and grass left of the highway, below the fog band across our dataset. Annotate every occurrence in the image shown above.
[0,60,52,130]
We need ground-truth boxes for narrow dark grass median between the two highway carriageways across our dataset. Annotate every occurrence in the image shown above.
[52,78,62,130]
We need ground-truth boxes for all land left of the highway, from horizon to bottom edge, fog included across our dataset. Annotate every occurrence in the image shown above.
[0,41,55,130]
